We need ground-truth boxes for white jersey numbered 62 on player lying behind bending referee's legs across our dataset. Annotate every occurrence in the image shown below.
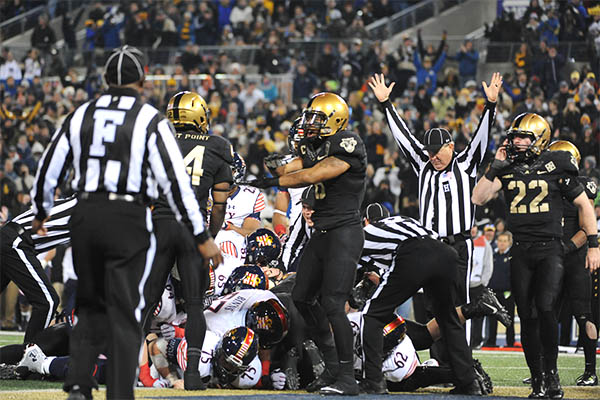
[348,312,419,382]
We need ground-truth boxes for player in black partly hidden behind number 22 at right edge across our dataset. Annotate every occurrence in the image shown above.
[548,140,598,386]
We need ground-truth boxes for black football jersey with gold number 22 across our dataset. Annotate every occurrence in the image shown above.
[499,151,583,241]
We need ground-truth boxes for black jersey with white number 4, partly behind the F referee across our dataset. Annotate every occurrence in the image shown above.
[153,131,233,217]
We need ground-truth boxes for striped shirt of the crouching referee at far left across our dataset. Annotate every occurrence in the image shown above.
[10,197,77,253]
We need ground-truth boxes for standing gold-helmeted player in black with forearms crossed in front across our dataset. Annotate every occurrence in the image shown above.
[247,93,367,395]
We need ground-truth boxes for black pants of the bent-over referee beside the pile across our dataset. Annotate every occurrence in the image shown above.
[362,238,475,386]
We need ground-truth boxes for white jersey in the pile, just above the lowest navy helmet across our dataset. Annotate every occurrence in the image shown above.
[204,289,279,336]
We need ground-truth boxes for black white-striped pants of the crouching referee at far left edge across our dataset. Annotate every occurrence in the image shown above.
[0,222,60,343]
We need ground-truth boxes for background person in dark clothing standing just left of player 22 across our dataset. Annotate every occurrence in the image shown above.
[484,232,515,347]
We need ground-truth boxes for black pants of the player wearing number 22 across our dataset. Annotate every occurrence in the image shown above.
[510,240,564,376]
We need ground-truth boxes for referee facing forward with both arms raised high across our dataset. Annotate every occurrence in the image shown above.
[369,73,502,340]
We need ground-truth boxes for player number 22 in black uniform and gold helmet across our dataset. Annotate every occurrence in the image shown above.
[472,113,600,399]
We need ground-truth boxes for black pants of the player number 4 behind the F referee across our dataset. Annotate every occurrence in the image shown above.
[144,218,209,369]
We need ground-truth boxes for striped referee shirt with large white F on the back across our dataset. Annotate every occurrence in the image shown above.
[31,87,205,236]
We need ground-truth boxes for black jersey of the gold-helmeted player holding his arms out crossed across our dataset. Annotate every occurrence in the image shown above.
[312,131,367,230]
